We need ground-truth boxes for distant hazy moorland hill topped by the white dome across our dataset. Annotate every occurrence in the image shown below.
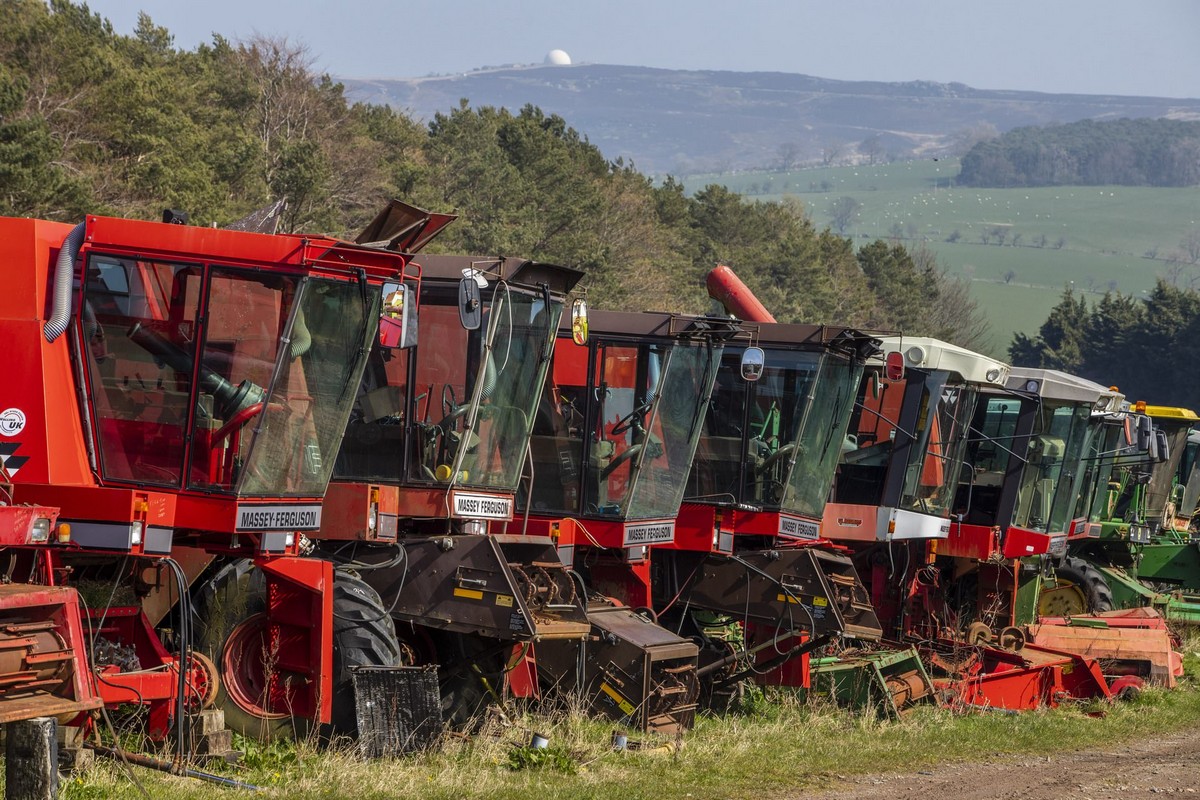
[342,65,1200,175]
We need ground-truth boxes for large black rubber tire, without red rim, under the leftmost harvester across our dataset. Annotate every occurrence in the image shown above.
[194,559,400,739]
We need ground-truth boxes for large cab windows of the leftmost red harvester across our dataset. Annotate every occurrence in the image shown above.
[82,254,378,495]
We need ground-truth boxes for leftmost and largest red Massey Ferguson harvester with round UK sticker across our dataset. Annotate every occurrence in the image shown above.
[0,216,418,747]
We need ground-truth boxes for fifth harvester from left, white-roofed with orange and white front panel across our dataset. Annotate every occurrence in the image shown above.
[817,336,1009,710]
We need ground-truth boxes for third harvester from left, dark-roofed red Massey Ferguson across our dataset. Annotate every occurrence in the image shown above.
[518,312,739,732]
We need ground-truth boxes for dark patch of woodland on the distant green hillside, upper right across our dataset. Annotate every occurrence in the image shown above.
[958,119,1200,187]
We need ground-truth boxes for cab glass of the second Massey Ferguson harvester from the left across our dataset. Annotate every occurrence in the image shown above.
[405,285,563,492]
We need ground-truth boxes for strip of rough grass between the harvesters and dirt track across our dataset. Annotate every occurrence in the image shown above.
[54,643,1200,800]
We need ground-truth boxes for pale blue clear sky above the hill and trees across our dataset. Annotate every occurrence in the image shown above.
[79,0,1200,98]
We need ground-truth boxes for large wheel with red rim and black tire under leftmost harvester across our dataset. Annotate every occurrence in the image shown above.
[194,559,400,740]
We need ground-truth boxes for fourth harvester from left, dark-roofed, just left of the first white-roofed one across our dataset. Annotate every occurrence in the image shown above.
[652,323,880,697]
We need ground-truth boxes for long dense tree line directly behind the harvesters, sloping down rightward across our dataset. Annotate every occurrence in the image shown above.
[0,0,985,347]
